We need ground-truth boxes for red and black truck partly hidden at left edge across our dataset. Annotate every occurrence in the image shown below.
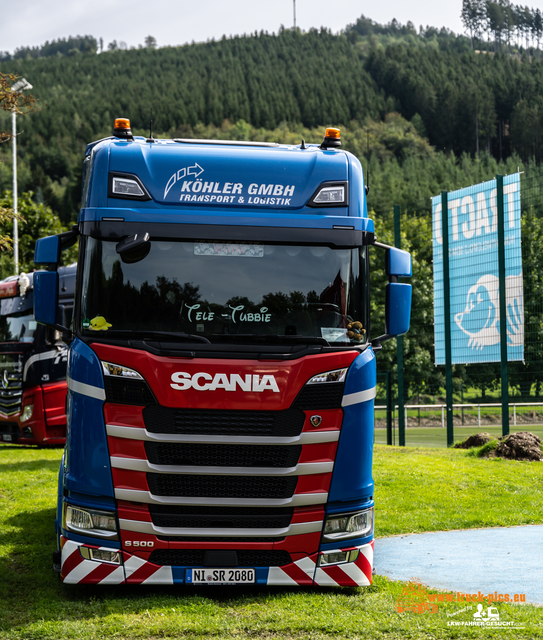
[0,265,76,446]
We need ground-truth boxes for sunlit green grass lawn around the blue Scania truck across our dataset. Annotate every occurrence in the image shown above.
[0,445,543,640]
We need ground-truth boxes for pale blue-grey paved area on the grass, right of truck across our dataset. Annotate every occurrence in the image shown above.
[374,525,543,604]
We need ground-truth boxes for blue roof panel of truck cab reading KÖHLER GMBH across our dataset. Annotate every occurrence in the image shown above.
[95,140,361,215]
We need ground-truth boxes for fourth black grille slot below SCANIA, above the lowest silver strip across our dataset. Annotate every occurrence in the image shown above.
[149,504,294,529]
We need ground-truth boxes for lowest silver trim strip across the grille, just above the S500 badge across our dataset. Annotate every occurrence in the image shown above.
[119,518,322,538]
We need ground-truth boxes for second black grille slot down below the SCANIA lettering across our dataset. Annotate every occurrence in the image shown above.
[145,442,302,468]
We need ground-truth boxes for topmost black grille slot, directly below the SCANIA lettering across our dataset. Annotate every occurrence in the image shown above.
[143,405,305,437]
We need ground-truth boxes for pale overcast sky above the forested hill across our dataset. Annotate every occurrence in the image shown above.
[0,0,472,53]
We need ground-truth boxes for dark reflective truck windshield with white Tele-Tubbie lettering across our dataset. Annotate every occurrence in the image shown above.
[79,237,366,346]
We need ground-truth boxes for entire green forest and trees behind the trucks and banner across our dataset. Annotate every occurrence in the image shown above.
[0,15,543,395]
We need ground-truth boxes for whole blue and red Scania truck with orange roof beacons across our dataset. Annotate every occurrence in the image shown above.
[35,119,411,587]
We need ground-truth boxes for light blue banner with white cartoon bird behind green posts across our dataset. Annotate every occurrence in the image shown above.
[432,173,524,364]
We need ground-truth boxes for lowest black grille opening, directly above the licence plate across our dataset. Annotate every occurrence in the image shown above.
[149,549,291,567]
